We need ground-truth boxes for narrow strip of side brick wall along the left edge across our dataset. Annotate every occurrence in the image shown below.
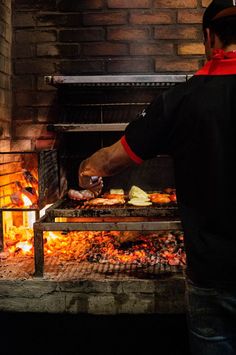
[0,0,12,151]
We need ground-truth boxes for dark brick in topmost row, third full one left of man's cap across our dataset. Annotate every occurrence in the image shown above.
[58,0,104,12]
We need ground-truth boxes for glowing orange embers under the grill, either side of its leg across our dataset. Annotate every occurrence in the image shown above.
[2,227,186,265]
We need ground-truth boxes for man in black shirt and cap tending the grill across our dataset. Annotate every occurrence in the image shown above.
[79,0,236,355]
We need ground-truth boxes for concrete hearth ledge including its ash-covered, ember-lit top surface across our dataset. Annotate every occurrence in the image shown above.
[0,254,185,315]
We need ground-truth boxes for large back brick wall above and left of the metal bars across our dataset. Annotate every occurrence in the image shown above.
[13,0,209,149]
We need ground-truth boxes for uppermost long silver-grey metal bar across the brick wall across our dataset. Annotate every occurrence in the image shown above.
[45,74,187,86]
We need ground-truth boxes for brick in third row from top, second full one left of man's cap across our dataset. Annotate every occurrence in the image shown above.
[107,28,149,41]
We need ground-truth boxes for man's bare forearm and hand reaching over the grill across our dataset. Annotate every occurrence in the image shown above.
[79,140,134,191]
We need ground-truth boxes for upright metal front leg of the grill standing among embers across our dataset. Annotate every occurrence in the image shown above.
[34,228,44,277]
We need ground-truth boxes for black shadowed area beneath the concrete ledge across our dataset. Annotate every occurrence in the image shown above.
[0,313,189,355]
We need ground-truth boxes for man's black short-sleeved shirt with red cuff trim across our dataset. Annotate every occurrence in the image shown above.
[123,52,236,287]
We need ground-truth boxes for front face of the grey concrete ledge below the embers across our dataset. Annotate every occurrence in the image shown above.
[0,274,184,315]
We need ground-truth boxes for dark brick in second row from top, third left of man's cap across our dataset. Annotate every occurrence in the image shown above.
[83,12,128,26]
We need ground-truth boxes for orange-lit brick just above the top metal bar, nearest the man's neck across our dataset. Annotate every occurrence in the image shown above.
[155,57,200,72]
